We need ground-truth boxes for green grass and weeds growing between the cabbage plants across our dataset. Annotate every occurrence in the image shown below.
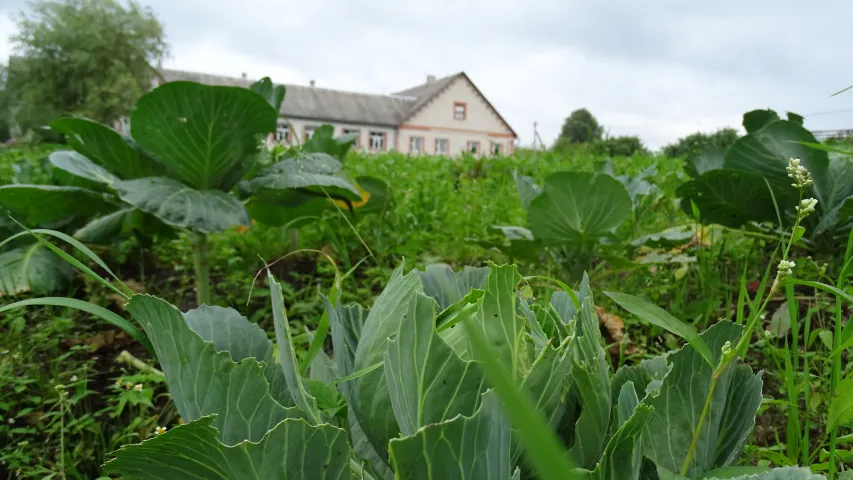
[0,142,851,478]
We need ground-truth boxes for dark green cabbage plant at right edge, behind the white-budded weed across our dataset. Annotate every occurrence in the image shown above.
[676,110,853,252]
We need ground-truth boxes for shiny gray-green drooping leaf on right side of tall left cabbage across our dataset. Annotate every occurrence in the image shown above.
[247,153,361,201]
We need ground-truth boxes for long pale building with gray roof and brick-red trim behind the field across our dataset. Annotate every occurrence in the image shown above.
[163,70,518,156]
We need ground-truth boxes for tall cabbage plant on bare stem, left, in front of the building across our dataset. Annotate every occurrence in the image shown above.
[0,78,376,304]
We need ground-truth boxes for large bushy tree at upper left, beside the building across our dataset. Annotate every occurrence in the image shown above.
[2,0,168,139]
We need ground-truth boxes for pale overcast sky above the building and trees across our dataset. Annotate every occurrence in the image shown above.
[0,0,853,148]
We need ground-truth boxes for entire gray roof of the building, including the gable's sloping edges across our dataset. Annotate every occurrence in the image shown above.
[162,70,518,136]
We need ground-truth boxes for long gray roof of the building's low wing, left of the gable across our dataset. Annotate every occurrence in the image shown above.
[162,70,419,126]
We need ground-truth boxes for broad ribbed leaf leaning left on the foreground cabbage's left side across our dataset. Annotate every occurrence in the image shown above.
[127,295,302,445]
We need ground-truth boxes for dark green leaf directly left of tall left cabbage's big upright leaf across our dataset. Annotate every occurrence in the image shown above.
[50,118,164,180]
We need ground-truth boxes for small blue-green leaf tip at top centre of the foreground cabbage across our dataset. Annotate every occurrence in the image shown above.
[415,263,489,311]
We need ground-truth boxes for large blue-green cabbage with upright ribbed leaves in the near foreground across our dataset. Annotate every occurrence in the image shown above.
[81,264,822,480]
